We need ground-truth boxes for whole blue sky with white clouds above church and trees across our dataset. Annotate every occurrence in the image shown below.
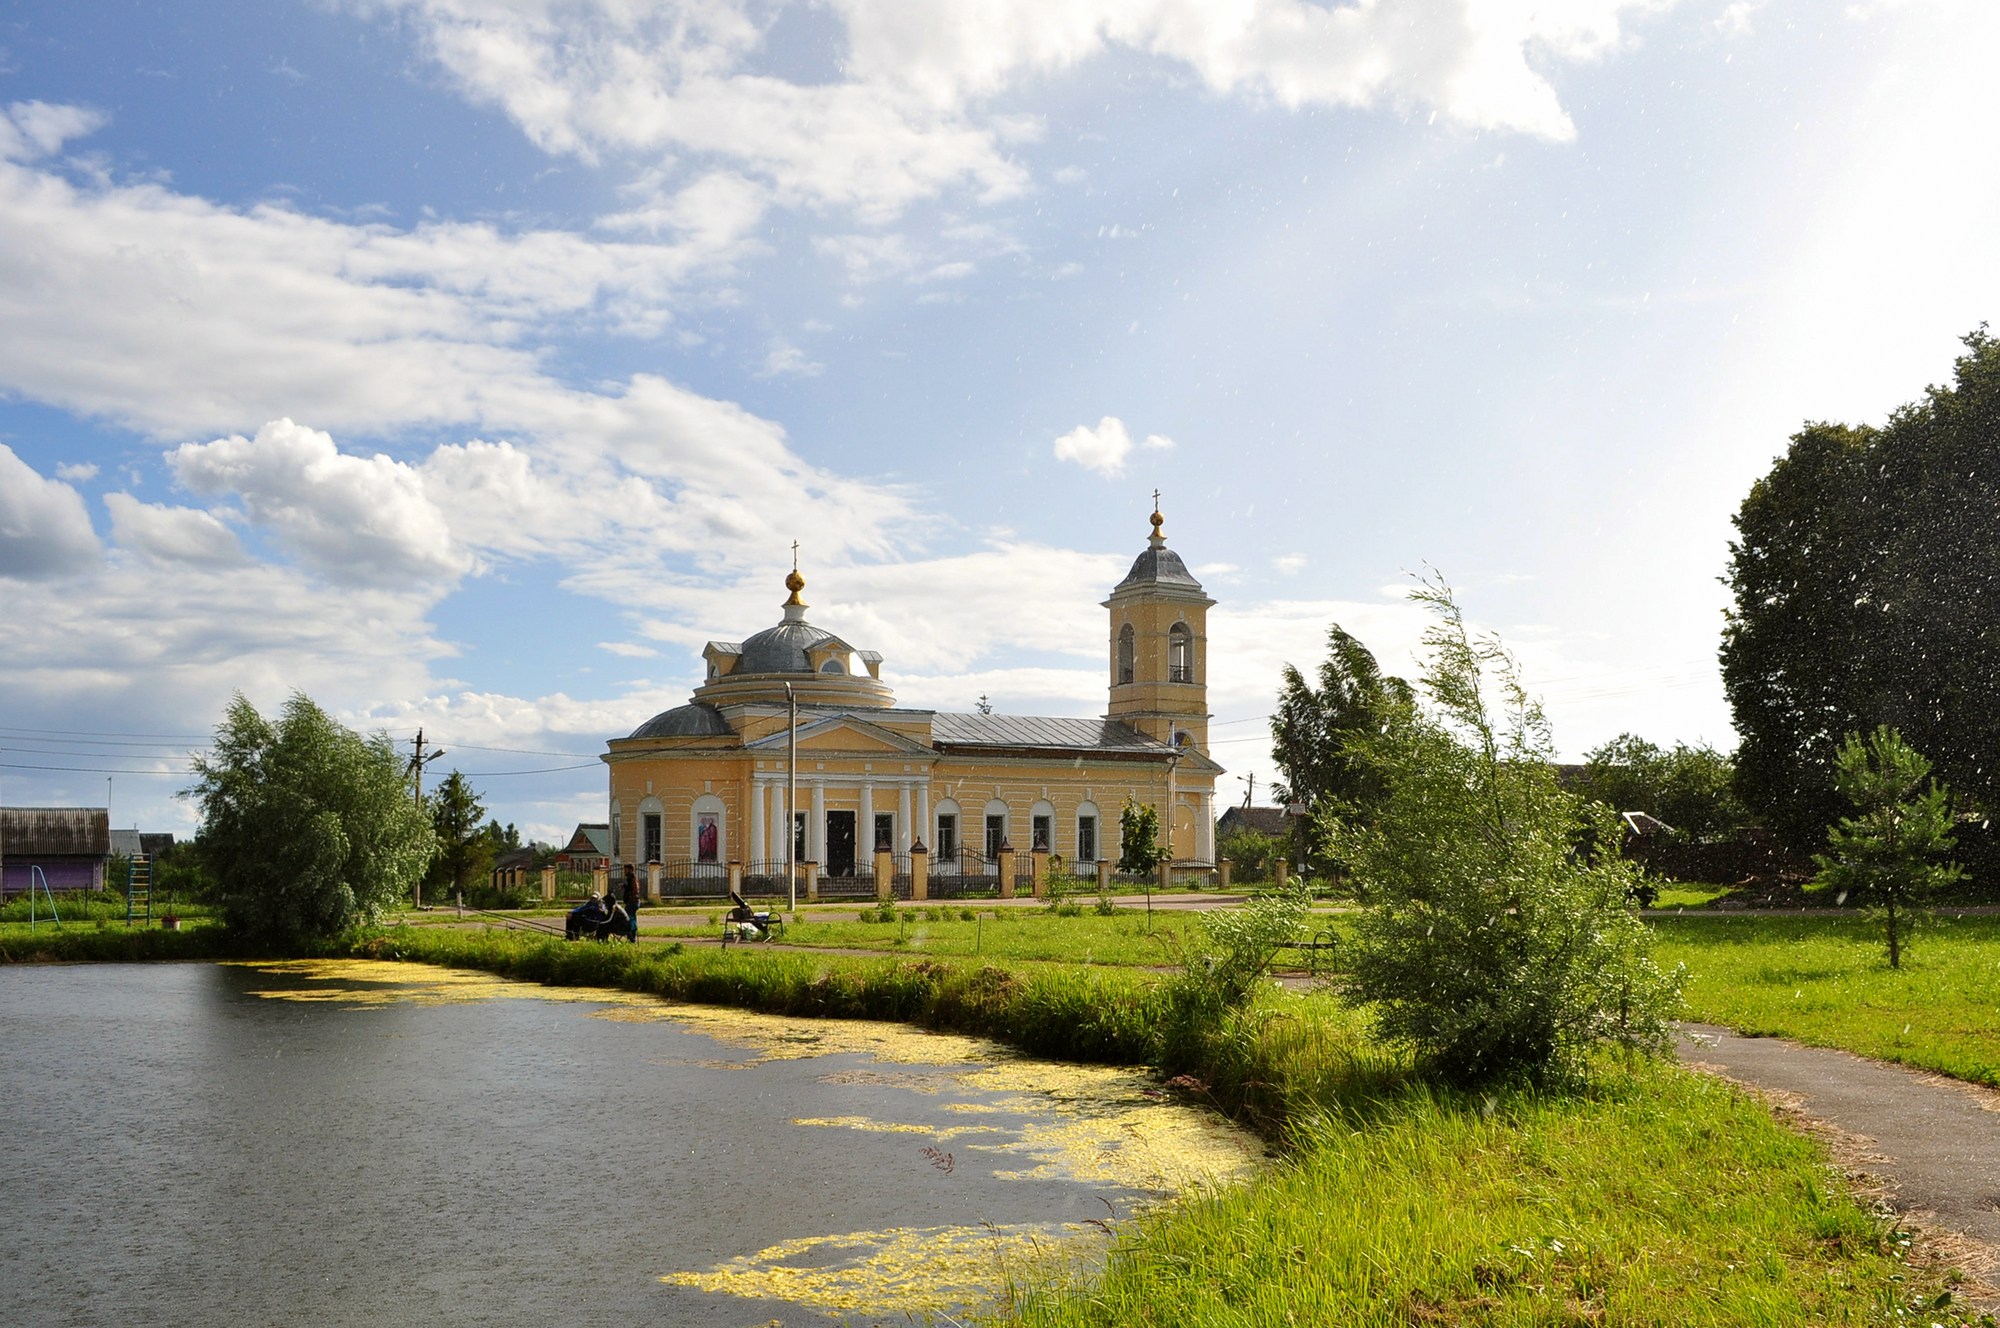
[0,0,2000,838]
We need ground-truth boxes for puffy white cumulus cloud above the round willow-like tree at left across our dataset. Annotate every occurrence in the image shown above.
[170,420,472,586]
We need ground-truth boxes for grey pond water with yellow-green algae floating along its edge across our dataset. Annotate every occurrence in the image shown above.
[0,962,1260,1328]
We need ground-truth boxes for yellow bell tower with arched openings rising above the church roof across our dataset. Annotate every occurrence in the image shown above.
[1104,492,1214,754]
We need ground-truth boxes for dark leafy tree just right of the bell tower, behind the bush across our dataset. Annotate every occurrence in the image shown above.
[1270,622,1410,866]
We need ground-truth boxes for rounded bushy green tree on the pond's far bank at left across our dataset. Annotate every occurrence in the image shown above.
[186,692,432,946]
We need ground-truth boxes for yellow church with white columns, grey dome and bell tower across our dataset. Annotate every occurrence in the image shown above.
[602,512,1222,888]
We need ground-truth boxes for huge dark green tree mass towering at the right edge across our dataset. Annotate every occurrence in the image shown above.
[1722,328,2000,850]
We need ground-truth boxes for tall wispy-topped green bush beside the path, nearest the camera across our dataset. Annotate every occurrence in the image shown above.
[1330,580,1678,1084]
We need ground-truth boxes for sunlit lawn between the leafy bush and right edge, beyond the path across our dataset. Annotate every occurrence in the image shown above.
[1654,914,2000,1088]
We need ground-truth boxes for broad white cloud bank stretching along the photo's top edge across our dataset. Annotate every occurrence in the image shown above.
[364,0,1674,233]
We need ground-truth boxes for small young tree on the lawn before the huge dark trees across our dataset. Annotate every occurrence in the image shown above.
[1812,724,1962,968]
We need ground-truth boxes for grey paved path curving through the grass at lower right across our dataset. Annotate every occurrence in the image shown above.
[1680,1024,2000,1252]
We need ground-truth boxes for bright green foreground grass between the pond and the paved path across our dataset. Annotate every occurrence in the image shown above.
[1014,1066,1958,1328]
